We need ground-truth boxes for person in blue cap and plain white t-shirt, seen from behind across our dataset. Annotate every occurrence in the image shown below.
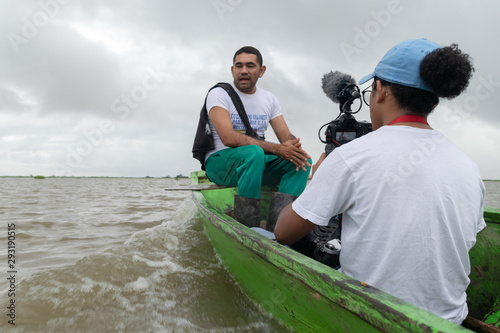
[275,39,486,324]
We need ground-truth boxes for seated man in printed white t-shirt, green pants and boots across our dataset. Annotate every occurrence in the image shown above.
[201,46,311,229]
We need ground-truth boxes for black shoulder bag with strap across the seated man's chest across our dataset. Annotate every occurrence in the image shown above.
[192,82,265,170]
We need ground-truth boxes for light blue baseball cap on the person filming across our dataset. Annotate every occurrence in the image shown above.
[359,38,441,92]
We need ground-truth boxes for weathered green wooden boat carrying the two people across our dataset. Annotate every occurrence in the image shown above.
[190,171,500,333]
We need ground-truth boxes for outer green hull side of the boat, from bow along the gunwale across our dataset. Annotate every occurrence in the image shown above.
[192,172,500,332]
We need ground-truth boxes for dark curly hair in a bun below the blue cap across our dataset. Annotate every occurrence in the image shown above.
[375,44,474,115]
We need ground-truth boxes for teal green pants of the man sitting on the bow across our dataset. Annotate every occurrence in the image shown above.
[205,145,312,198]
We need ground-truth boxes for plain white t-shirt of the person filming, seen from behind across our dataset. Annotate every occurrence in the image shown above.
[293,126,486,324]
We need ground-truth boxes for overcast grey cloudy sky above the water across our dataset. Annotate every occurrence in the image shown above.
[0,0,500,179]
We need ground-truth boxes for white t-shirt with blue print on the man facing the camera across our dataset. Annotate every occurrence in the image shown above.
[205,83,283,161]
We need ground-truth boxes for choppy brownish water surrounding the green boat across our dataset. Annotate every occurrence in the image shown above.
[0,178,500,332]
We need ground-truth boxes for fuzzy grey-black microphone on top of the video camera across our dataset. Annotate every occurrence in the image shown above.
[321,71,361,105]
